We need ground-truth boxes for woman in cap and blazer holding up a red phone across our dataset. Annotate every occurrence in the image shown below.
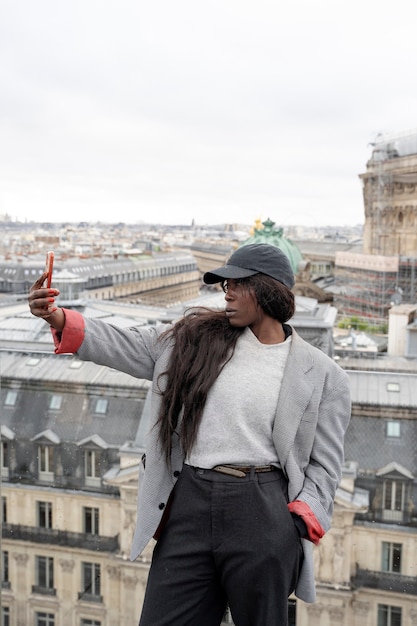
[29,244,350,626]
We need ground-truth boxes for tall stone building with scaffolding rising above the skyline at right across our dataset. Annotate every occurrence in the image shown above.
[335,131,417,324]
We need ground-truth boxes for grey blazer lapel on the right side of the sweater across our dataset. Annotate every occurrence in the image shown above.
[272,332,314,468]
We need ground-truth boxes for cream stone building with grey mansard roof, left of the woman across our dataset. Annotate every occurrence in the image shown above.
[0,351,152,626]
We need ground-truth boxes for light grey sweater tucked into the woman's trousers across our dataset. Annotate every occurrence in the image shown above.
[186,328,291,469]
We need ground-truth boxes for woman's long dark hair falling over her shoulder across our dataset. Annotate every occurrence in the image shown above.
[158,274,295,463]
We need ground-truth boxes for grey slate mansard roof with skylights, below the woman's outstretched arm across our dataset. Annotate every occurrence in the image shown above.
[0,352,150,447]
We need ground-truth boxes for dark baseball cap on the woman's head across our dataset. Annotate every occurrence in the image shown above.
[203,243,295,289]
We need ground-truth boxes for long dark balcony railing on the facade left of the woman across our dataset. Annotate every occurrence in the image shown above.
[2,523,119,552]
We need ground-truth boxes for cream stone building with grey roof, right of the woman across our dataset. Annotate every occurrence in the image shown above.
[297,370,417,626]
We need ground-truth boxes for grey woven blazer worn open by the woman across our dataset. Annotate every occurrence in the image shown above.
[78,319,350,602]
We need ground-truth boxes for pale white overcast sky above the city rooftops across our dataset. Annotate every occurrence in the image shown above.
[0,0,417,225]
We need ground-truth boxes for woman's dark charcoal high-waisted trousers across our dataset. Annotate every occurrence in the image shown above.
[139,465,303,626]
